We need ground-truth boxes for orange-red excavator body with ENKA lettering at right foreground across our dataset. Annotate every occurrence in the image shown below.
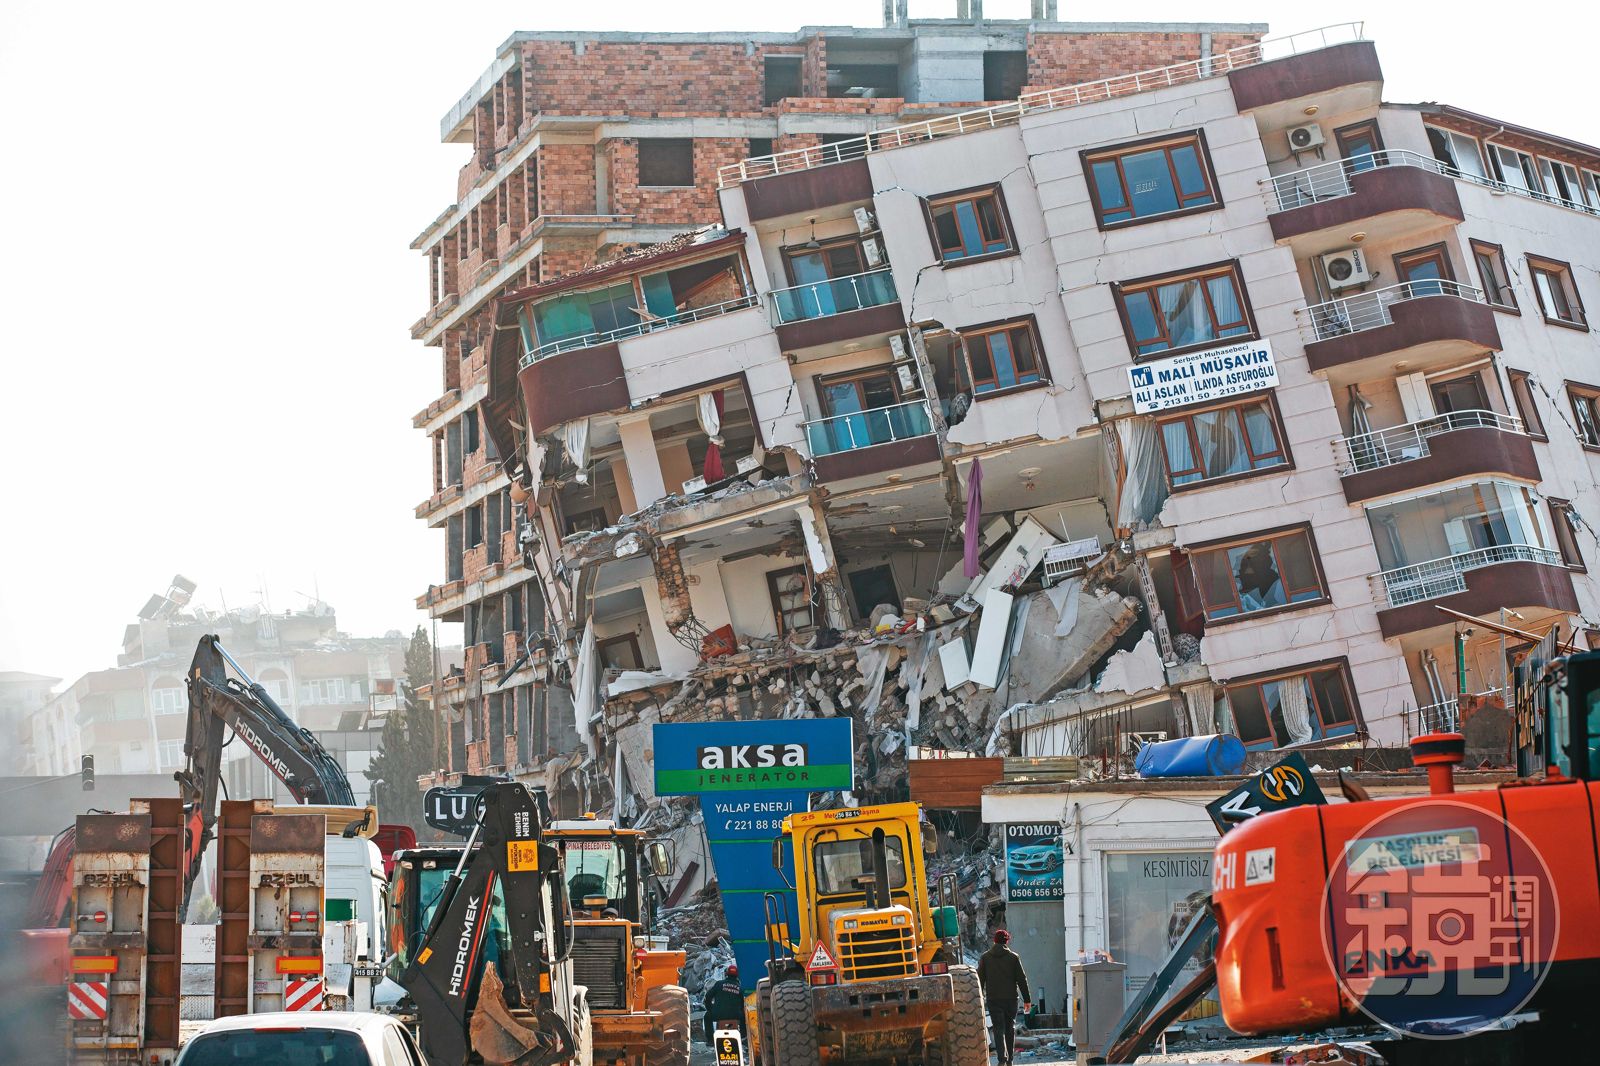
[1211,651,1600,1063]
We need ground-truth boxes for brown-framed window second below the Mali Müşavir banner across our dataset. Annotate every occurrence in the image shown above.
[1190,528,1328,621]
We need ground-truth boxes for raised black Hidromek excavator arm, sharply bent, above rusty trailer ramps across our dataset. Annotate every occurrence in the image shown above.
[174,635,355,908]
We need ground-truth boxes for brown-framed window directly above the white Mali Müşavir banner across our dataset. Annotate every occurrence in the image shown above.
[1114,262,1256,359]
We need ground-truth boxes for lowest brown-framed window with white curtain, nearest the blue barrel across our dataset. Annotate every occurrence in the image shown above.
[1218,663,1355,749]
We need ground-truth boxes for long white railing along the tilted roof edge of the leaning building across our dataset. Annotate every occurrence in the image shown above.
[717,22,1366,189]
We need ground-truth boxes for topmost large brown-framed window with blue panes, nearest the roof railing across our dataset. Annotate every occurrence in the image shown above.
[1083,131,1222,229]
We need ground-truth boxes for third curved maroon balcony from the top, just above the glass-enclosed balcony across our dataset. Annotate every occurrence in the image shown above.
[1334,411,1539,503]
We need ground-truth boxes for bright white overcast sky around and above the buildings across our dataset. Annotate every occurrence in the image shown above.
[0,0,1600,679]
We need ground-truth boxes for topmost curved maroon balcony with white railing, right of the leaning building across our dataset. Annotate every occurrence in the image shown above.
[1261,150,1466,249]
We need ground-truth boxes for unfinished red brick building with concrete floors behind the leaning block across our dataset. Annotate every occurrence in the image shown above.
[411,0,1266,804]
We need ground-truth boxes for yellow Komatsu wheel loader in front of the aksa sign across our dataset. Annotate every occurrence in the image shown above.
[754,804,989,1066]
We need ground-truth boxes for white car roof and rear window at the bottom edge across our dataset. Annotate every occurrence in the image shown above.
[173,1012,424,1066]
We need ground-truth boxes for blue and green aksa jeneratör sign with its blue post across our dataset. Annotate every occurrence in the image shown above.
[653,719,854,992]
